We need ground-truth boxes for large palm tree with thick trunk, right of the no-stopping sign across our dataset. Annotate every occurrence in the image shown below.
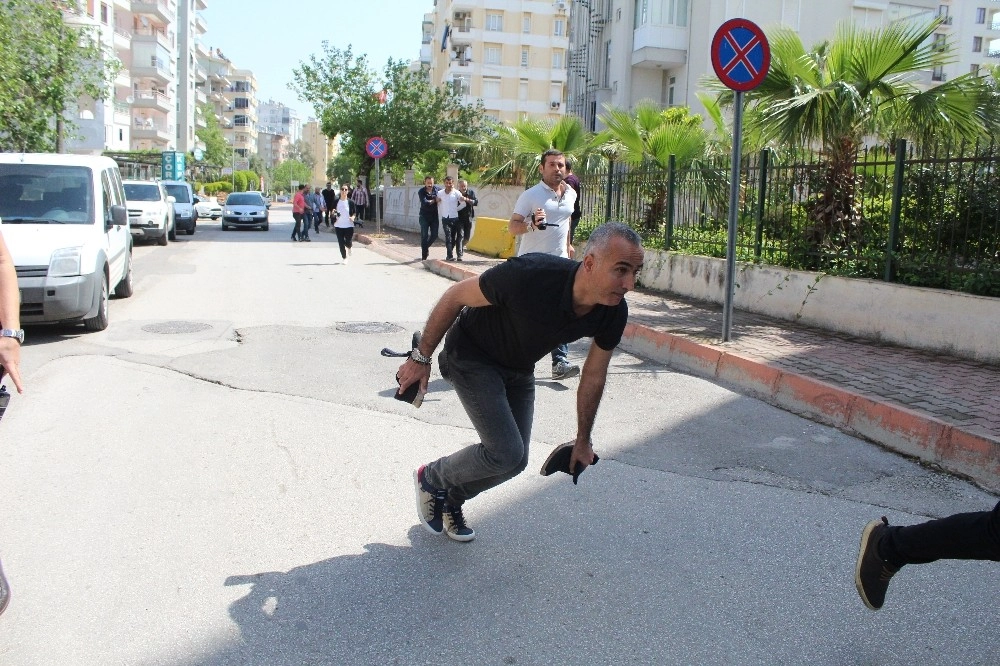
[746,19,998,245]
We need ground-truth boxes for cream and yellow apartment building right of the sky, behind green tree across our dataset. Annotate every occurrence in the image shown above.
[420,0,573,122]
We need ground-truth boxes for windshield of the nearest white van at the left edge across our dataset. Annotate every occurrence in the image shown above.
[0,164,94,224]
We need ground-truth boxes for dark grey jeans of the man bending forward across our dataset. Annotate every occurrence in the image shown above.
[424,346,535,506]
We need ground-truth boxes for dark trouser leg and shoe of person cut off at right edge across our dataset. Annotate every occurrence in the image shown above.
[854,502,1000,610]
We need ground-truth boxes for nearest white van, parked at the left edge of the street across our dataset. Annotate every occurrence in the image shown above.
[0,153,132,331]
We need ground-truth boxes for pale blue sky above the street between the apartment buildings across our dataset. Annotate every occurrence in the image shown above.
[201,0,434,122]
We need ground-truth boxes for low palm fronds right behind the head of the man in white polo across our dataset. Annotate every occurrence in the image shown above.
[446,116,596,185]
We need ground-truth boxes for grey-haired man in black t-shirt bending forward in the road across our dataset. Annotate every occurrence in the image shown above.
[396,223,643,541]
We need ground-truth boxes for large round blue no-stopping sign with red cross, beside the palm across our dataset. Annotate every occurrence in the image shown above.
[712,18,771,92]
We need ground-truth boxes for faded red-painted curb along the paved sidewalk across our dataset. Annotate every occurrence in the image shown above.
[358,234,1000,492]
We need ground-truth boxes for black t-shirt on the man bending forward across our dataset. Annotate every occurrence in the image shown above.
[446,253,628,370]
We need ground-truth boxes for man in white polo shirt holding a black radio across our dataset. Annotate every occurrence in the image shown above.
[507,149,580,380]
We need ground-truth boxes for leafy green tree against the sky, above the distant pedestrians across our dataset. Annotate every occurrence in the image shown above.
[292,41,483,182]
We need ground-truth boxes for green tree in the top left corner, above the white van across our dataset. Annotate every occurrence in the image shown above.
[0,0,120,152]
